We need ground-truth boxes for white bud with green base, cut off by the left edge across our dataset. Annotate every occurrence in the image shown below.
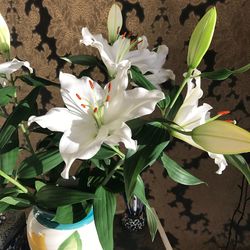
[0,14,10,55]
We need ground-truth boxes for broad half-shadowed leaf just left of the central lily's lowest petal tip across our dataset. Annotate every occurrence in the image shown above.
[17,149,63,179]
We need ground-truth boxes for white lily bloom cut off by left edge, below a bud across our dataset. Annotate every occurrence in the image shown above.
[0,58,33,86]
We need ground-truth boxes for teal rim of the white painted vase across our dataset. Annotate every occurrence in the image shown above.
[33,207,94,230]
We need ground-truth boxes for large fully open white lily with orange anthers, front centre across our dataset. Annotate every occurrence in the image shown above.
[28,61,164,178]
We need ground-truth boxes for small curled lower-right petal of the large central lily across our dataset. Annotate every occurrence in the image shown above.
[105,123,137,150]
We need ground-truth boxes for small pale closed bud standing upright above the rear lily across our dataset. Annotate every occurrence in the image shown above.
[107,4,122,44]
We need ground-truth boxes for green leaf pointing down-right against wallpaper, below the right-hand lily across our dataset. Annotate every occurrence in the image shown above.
[161,153,204,185]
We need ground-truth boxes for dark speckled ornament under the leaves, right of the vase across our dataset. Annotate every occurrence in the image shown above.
[122,196,146,232]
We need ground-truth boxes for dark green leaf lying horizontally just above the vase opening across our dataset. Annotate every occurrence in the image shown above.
[36,185,95,209]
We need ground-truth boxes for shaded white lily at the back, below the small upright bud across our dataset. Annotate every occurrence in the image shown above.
[80,27,175,85]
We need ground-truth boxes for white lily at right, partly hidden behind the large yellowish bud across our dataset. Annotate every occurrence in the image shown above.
[173,70,228,174]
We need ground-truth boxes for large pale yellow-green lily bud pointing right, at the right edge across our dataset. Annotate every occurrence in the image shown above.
[192,120,250,154]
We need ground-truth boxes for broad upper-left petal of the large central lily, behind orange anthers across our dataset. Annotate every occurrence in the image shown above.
[59,72,105,118]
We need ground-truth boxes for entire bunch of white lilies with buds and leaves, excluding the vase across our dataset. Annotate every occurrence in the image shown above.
[0,4,250,249]
